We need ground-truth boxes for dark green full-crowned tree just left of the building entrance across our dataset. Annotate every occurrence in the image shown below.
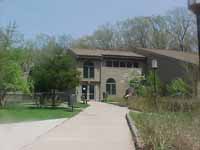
[31,41,80,106]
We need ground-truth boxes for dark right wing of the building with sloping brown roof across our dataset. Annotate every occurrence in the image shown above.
[131,48,200,96]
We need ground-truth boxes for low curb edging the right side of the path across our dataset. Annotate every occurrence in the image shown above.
[126,113,145,150]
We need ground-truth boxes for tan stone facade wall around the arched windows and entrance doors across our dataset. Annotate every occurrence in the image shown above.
[77,59,144,101]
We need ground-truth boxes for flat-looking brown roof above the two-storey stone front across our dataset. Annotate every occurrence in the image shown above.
[71,49,145,58]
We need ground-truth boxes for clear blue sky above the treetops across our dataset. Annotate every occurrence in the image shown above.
[0,0,187,39]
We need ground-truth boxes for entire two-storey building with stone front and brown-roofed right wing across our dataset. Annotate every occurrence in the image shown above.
[70,48,200,101]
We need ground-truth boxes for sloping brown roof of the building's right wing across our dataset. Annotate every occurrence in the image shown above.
[137,48,199,64]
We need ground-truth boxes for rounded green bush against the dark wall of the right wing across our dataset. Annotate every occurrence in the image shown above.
[167,78,192,97]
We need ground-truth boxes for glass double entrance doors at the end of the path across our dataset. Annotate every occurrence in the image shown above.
[82,84,95,100]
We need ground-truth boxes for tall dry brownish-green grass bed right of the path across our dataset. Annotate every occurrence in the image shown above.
[108,97,200,150]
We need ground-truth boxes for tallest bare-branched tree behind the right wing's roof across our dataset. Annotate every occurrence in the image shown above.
[166,8,194,51]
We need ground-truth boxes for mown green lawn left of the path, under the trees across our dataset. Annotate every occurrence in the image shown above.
[0,104,88,123]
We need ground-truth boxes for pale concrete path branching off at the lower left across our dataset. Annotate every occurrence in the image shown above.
[0,119,66,150]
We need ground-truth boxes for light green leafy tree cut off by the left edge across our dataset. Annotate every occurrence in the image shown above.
[0,51,29,107]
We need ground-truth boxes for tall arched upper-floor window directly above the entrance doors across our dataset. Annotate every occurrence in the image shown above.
[83,62,94,79]
